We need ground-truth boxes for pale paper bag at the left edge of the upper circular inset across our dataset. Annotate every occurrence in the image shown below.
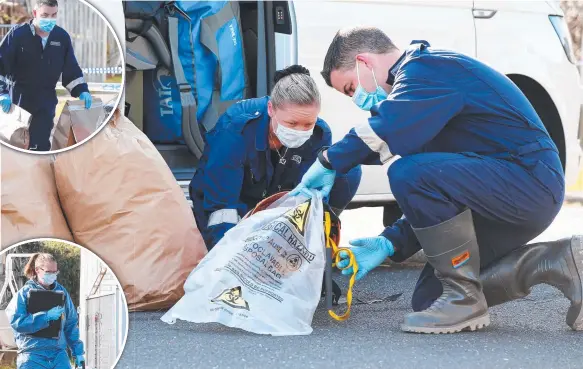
[0,104,31,150]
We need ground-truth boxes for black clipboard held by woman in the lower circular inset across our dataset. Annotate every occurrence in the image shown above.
[26,290,65,339]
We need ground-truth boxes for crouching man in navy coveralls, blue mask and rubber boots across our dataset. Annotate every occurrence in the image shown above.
[292,28,583,333]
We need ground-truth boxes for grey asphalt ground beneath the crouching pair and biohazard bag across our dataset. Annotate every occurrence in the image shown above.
[116,203,583,369]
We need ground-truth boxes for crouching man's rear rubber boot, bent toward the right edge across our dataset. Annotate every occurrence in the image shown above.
[480,236,583,331]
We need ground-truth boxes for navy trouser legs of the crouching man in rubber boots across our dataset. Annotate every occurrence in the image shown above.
[383,150,565,311]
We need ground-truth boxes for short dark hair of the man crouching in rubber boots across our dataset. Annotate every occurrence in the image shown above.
[320,27,397,87]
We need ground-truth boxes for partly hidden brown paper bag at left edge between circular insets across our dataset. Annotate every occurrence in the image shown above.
[0,146,73,249]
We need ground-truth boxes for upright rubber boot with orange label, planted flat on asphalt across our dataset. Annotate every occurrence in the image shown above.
[401,210,490,333]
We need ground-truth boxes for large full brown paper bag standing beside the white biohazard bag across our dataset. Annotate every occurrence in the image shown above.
[55,111,206,311]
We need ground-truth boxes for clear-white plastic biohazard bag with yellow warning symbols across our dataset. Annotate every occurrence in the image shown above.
[161,191,326,336]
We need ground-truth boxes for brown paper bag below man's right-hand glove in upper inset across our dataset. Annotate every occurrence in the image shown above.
[51,98,105,151]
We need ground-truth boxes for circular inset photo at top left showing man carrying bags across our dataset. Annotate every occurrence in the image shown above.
[0,0,125,154]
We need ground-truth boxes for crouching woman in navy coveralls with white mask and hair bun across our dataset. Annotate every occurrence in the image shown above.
[189,65,362,250]
